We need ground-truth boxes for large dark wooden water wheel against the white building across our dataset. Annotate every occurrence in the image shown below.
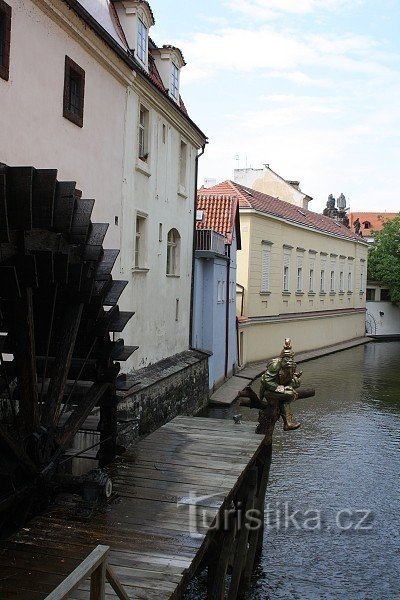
[0,165,136,528]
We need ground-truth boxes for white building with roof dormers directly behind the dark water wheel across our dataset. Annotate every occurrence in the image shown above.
[0,0,206,370]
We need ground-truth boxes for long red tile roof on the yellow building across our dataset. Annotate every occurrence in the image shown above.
[199,181,368,242]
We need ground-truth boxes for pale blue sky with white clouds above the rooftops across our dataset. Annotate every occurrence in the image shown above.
[150,0,400,212]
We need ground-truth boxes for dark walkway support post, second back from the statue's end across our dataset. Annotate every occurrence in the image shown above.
[228,466,257,600]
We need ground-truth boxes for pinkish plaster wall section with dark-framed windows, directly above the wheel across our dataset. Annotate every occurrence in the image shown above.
[0,0,126,248]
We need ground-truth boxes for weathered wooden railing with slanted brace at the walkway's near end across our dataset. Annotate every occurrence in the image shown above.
[45,546,130,600]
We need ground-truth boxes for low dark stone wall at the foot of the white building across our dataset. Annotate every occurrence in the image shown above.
[118,350,208,446]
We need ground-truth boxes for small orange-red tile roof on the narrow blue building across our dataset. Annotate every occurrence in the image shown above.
[196,195,238,244]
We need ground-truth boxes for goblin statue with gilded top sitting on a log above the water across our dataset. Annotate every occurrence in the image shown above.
[239,338,315,434]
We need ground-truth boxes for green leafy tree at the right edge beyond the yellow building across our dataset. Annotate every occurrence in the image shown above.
[368,214,400,304]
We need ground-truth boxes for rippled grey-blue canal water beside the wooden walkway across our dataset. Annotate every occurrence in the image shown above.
[188,342,400,600]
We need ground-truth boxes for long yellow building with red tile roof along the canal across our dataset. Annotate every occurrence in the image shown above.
[201,181,368,365]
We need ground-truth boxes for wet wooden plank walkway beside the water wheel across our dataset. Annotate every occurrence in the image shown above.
[0,417,264,600]
